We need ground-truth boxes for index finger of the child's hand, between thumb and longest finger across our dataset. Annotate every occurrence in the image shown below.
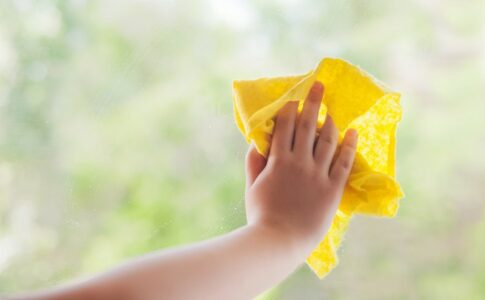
[270,101,298,155]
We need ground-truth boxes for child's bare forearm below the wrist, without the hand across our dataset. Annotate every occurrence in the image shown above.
[12,225,304,300]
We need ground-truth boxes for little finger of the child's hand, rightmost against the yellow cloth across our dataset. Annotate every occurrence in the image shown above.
[330,129,357,186]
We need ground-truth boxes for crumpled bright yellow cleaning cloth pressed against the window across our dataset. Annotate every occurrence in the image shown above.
[233,58,403,278]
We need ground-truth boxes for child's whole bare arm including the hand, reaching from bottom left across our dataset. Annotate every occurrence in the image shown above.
[6,82,357,300]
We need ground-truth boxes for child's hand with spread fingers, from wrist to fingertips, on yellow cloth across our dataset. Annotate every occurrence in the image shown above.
[246,81,357,256]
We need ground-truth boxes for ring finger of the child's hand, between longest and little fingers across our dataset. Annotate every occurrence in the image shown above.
[314,115,338,174]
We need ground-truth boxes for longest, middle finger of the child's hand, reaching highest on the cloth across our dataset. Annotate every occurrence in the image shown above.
[293,81,324,156]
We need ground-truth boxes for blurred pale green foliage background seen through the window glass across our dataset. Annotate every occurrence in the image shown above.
[0,0,485,299]
